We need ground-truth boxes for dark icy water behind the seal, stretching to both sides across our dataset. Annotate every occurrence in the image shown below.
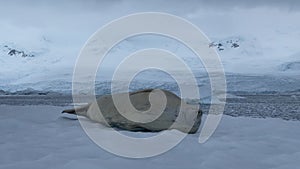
[0,94,300,120]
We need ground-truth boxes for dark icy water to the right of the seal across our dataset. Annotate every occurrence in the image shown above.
[202,95,300,120]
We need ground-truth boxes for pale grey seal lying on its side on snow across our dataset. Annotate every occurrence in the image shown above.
[62,89,202,134]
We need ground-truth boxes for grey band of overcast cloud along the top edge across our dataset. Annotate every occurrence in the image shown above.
[0,0,300,27]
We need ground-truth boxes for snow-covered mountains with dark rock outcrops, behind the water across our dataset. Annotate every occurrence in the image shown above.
[0,32,300,94]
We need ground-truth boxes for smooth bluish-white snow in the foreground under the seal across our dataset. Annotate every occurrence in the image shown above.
[0,105,300,169]
